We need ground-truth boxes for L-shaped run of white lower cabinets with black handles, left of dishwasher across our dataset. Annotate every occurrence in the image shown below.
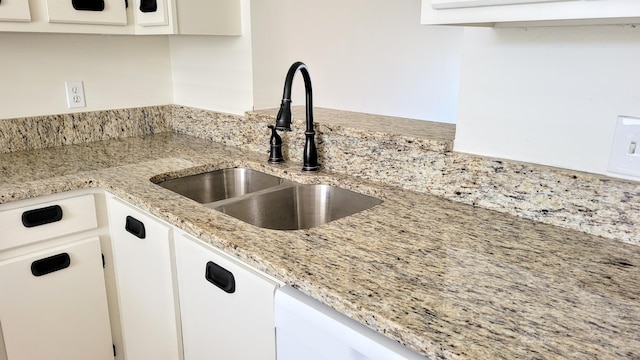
[0,188,282,360]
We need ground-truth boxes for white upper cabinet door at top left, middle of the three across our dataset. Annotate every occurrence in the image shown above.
[46,0,127,25]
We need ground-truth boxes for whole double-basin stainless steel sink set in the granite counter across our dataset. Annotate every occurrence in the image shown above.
[157,168,382,230]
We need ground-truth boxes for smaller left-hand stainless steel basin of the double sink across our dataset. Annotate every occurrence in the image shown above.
[158,168,284,204]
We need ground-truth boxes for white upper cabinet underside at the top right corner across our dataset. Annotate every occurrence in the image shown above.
[421,0,640,26]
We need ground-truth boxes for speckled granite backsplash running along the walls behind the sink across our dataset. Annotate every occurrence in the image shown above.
[0,105,640,245]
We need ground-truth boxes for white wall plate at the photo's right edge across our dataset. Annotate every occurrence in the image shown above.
[609,116,640,178]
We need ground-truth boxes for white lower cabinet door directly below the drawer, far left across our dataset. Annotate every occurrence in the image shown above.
[0,237,113,360]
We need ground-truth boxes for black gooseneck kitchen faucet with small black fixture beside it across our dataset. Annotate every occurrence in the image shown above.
[269,62,320,171]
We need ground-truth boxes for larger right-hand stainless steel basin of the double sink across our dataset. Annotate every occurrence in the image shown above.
[214,185,382,230]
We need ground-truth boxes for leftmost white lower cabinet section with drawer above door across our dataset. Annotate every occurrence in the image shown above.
[0,193,121,360]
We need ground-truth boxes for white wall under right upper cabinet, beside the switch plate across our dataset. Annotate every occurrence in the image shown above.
[454,26,640,176]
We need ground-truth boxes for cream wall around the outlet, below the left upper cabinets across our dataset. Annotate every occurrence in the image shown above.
[0,33,172,119]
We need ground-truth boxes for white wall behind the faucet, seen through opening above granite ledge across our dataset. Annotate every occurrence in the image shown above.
[251,0,463,122]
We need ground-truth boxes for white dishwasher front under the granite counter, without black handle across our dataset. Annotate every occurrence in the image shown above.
[275,286,425,360]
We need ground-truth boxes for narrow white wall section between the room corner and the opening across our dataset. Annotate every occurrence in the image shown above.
[169,0,253,114]
